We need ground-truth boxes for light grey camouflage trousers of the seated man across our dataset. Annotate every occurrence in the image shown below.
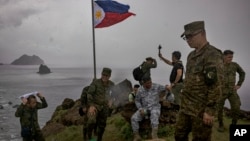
[131,108,161,133]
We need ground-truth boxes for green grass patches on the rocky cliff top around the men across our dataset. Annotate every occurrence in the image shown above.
[46,114,250,141]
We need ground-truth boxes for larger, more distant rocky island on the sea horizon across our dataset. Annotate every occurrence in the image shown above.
[11,54,44,65]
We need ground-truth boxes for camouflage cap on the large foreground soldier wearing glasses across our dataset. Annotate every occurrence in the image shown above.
[181,21,205,37]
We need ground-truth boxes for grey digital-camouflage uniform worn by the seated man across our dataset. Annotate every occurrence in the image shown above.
[131,83,165,133]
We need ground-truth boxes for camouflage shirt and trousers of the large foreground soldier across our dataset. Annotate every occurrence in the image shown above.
[175,43,223,141]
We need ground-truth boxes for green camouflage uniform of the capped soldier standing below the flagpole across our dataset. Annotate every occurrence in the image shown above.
[87,79,114,140]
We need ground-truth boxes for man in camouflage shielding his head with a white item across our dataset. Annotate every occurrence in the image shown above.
[15,93,48,141]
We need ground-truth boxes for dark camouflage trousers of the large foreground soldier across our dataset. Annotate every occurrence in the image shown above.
[175,113,212,141]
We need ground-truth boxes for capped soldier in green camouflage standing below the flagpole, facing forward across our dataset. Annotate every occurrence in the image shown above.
[87,68,114,141]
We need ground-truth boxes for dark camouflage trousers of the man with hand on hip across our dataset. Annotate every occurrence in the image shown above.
[218,91,241,124]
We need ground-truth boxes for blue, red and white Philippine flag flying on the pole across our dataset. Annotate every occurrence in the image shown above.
[94,0,135,28]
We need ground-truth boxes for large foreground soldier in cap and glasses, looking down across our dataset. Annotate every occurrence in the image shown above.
[175,21,223,141]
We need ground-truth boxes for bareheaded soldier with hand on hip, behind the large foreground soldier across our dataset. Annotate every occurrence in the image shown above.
[218,50,245,132]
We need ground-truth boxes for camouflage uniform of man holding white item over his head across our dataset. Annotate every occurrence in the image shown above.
[15,98,48,141]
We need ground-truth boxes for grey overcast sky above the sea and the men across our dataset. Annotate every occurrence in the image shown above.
[0,0,250,67]
